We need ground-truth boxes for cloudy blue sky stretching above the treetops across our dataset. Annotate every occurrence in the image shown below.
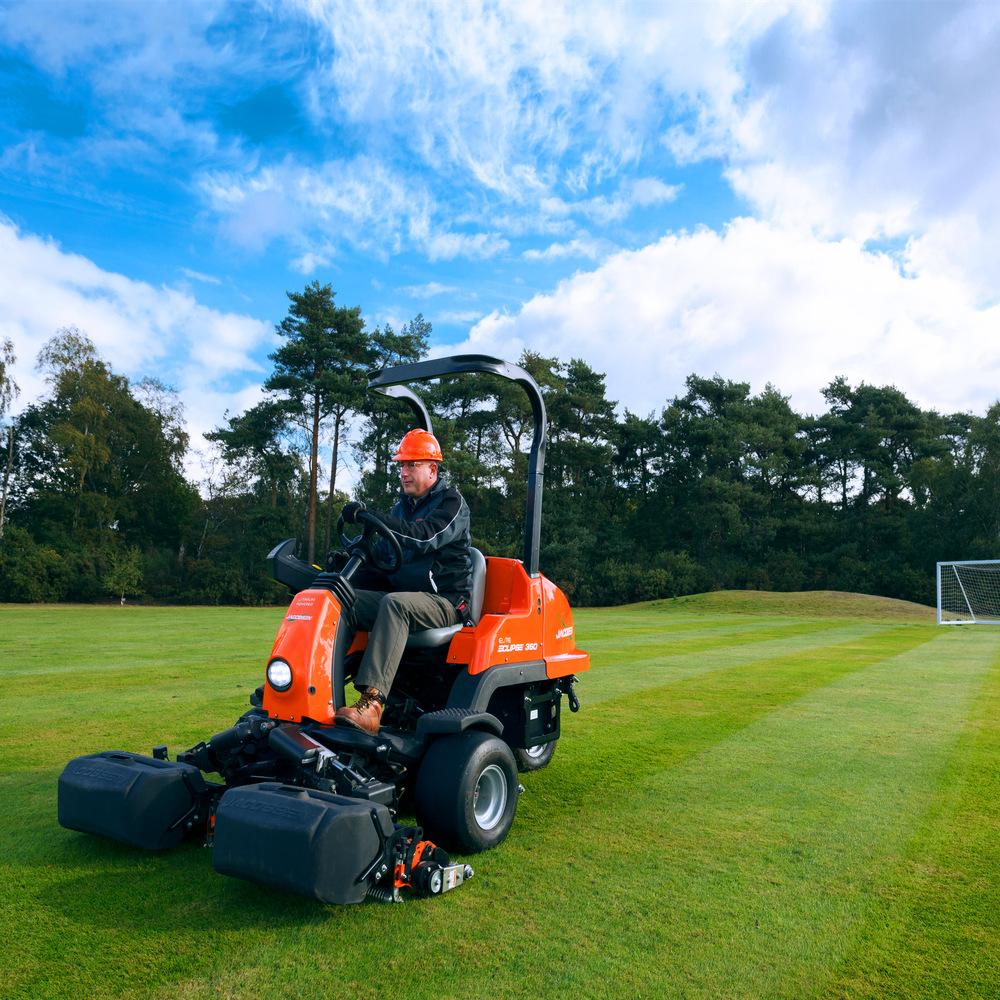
[0,0,1000,484]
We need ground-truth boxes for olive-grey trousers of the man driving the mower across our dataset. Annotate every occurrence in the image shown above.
[351,590,461,697]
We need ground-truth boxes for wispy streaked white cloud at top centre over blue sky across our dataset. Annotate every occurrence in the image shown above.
[299,0,790,195]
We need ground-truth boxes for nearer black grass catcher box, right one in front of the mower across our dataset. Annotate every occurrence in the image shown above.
[212,782,395,903]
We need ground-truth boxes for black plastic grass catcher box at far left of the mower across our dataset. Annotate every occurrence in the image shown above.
[59,750,209,851]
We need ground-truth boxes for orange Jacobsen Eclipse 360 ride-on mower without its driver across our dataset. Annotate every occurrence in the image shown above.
[59,355,590,903]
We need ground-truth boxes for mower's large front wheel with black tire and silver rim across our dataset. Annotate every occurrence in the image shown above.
[416,730,518,854]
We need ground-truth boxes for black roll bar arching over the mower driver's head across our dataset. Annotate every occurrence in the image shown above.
[368,354,548,576]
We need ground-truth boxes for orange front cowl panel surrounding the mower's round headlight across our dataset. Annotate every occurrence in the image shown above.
[264,590,340,723]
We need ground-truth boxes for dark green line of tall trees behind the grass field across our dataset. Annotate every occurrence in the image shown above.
[0,282,1000,605]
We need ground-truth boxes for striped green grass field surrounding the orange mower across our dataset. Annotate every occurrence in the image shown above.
[0,594,1000,1000]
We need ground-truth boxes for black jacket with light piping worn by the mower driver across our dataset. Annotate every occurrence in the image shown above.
[358,479,472,608]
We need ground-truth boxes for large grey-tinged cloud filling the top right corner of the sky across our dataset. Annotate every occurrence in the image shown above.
[670,2,1000,297]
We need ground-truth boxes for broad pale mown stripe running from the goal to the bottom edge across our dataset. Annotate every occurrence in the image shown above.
[496,633,997,997]
